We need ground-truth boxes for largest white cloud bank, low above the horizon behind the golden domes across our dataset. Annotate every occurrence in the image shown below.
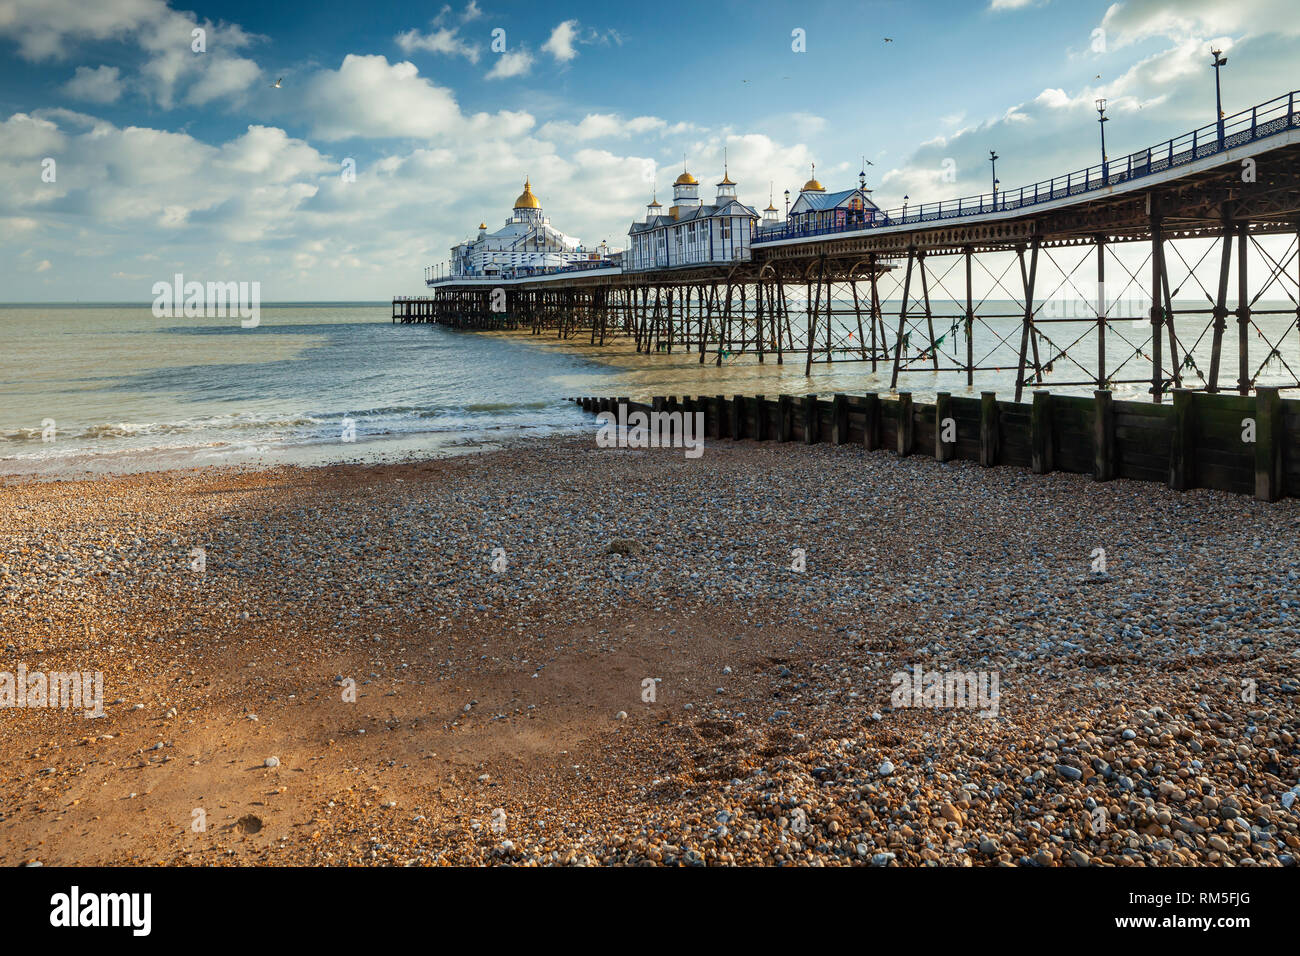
[0,93,820,299]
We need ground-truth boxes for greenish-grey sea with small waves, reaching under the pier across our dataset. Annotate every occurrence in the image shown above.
[0,302,1297,477]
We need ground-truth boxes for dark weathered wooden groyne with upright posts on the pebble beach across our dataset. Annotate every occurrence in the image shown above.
[572,388,1300,501]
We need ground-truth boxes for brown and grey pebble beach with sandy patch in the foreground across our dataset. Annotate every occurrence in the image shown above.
[0,429,1300,866]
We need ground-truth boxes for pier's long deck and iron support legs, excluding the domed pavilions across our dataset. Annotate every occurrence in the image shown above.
[393,92,1300,403]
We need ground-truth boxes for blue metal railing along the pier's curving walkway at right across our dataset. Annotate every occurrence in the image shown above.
[753,92,1300,245]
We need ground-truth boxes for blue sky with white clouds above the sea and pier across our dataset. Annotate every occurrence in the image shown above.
[0,0,1300,302]
